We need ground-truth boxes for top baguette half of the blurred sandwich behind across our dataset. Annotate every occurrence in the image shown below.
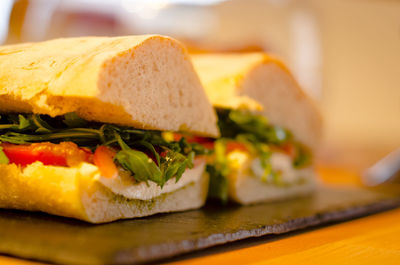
[192,53,322,148]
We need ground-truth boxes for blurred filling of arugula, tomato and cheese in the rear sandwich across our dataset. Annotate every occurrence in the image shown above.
[200,109,312,202]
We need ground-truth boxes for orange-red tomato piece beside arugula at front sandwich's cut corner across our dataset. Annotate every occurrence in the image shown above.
[93,145,118,178]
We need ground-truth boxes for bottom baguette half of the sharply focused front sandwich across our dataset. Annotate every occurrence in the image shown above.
[0,162,208,223]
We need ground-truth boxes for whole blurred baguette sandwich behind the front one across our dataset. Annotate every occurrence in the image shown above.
[192,53,321,204]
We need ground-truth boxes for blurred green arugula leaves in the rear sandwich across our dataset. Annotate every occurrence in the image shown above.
[206,109,312,202]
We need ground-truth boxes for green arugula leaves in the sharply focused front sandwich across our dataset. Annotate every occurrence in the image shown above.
[0,113,207,187]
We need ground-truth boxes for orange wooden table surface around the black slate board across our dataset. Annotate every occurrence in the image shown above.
[0,167,400,265]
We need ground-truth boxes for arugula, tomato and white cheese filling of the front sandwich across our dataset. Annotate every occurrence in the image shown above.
[0,113,208,194]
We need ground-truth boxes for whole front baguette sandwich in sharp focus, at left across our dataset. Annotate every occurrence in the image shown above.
[0,35,219,223]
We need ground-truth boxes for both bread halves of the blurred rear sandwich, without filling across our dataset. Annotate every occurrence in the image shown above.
[192,53,321,205]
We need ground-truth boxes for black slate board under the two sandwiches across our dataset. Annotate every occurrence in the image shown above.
[0,184,400,264]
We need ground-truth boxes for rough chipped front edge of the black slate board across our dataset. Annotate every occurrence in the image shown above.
[113,198,400,264]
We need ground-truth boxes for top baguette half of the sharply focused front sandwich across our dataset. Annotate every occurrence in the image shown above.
[0,35,218,136]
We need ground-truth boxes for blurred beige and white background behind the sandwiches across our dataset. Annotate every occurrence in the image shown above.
[0,0,400,169]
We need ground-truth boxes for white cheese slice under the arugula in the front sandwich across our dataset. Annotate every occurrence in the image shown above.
[98,160,205,200]
